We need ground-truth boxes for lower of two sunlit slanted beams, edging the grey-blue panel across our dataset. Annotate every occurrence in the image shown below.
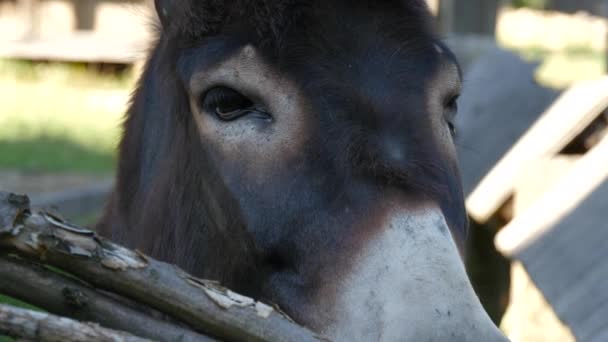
[495,132,608,256]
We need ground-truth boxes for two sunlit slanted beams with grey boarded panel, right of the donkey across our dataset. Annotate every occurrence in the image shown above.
[467,78,608,341]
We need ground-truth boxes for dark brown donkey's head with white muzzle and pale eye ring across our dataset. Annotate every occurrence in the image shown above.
[98,0,504,341]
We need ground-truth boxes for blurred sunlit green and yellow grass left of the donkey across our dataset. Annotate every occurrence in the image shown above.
[0,60,134,173]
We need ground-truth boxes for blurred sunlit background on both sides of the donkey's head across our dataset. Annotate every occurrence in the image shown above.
[0,0,608,341]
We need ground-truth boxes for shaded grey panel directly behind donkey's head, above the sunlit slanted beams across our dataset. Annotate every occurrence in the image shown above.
[448,46,559,197]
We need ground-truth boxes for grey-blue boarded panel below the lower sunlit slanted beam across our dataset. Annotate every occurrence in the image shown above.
[513,179,608,341]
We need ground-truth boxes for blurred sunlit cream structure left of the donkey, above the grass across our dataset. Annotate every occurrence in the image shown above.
[0,0,154,64]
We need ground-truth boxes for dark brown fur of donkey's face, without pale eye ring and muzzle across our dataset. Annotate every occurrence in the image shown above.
[98,0,466,328]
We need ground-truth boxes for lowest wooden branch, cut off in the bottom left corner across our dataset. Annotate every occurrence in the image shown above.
[0,304,150,342]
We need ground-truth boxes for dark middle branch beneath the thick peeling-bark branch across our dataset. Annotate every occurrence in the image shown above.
[0,256,216,341]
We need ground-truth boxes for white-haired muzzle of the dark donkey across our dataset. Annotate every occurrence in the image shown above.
[323,209,504,341]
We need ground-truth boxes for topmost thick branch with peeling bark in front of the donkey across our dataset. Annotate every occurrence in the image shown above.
[0,193,320,341]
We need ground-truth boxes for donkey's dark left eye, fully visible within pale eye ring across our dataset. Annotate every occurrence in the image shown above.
[201,87,265,121]
